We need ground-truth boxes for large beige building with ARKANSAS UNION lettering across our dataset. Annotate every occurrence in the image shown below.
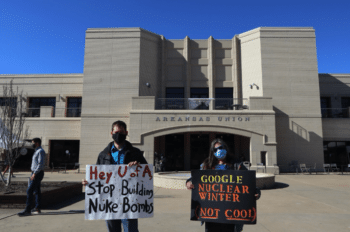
[0,27,350,173]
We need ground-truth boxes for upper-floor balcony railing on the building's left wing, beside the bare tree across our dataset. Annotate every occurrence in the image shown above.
[22,107,81,118]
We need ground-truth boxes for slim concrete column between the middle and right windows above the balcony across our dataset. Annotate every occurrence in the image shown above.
[208,36,215,110]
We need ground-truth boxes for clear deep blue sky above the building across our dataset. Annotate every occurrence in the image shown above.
[0,0,350,74]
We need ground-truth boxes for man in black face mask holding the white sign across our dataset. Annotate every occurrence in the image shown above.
[82,121,147,232]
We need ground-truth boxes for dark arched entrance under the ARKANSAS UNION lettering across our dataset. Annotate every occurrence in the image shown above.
[154,131,250,171]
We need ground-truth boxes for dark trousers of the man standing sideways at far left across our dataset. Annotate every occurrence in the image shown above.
[25,171,44,212]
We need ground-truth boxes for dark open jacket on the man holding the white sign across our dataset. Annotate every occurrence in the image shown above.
[96,141,147,164]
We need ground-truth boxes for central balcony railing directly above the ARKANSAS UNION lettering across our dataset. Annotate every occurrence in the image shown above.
[155,98,248,110]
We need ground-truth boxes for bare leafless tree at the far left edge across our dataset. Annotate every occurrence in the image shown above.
[0,80,29,186]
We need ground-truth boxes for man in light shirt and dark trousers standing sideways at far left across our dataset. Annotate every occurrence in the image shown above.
[18,138,46,216]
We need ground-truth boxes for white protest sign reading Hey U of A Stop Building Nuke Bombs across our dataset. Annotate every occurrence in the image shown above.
[85,164,154,220]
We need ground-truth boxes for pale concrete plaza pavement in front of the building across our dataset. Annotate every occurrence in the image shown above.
[0,173,350,232]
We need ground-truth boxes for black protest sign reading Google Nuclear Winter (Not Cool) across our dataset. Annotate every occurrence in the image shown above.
[191,170,256,224]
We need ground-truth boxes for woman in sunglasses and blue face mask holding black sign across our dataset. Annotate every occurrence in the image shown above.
[186,139,260,232]
